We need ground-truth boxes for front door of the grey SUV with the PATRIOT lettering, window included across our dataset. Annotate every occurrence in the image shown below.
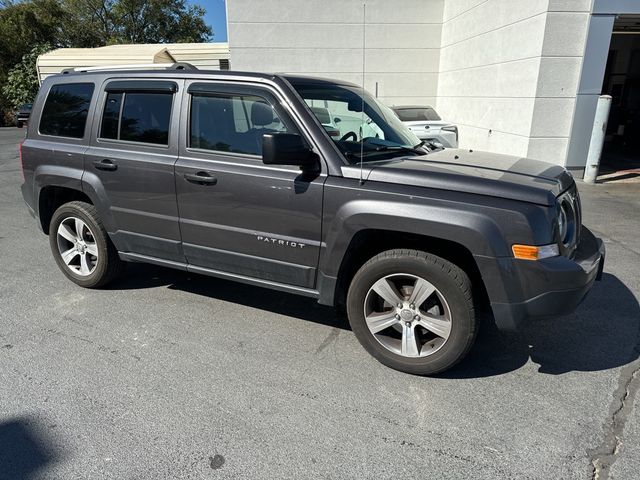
[175,81,325,288]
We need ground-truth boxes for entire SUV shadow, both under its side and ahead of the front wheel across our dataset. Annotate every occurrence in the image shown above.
[110,264,640,379]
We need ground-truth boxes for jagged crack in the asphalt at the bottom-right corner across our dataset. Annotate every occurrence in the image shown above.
[588,356,640,480]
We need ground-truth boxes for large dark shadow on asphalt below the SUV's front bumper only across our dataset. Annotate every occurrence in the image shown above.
[442,273,640,378]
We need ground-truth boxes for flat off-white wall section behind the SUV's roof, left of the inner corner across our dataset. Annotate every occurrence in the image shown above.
[227,0,444,105]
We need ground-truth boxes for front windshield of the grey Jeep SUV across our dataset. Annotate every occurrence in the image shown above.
[291,80,426,163]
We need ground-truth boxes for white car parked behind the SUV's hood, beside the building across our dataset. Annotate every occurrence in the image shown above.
[391,105,458,148]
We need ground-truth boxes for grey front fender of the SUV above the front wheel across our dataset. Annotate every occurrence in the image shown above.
[317,178,555,304]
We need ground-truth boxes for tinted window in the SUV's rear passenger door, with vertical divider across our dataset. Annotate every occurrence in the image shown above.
[100,92,173,145]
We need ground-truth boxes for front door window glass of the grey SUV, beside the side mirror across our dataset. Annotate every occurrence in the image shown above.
[189,93,297,155]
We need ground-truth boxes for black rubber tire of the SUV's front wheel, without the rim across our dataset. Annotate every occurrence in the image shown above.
[347,250,477,375]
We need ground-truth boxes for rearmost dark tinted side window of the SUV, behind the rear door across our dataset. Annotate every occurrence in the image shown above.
[40,83,94,138]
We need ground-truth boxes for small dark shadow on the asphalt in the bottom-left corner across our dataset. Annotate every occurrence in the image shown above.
[0,417,61,480]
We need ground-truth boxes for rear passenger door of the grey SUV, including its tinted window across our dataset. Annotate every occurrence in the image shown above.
[83,78,184,263]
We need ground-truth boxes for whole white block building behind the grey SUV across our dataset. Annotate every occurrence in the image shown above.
[227,0,640,174]
